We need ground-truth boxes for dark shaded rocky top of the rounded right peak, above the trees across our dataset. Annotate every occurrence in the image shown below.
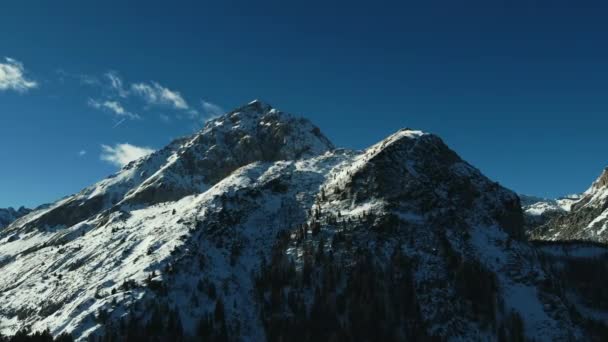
[327,129,523,239]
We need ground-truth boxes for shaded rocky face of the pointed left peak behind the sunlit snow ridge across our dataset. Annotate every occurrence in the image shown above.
[9,100,333,229]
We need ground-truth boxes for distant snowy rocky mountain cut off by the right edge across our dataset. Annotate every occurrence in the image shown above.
[531,168,608,243]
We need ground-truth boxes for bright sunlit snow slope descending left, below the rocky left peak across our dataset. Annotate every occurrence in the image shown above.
[0,148,350,340]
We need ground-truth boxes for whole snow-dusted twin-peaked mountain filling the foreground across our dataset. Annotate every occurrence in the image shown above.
[0,101,603,341]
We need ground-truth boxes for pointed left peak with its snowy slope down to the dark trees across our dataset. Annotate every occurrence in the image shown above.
[0,101,348,340]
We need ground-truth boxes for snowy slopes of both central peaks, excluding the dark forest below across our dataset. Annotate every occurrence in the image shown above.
[0,101,600,341]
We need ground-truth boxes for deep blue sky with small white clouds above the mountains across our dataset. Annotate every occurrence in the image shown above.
[0,0,608,207]
